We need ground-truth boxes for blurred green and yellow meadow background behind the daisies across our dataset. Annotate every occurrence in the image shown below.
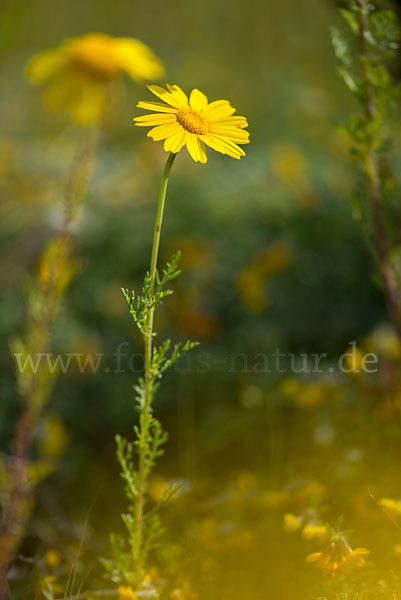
[0,0,401,599]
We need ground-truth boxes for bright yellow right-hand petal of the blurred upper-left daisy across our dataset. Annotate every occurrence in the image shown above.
[114,38,164,82]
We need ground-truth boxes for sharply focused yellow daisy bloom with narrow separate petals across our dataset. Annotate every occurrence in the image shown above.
[134,85,249,163]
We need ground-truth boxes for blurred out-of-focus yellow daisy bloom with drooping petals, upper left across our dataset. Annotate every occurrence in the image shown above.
[27,33,164,125]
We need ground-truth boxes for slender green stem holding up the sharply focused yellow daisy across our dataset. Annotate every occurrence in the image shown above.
[134,153,176,561]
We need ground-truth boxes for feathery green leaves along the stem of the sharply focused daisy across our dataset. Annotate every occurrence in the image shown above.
[102,252,197,589]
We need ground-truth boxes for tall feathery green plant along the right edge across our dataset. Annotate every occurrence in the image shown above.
[332,0,401,337]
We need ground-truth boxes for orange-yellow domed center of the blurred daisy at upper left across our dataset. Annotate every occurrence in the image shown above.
[70,34,120,79]
